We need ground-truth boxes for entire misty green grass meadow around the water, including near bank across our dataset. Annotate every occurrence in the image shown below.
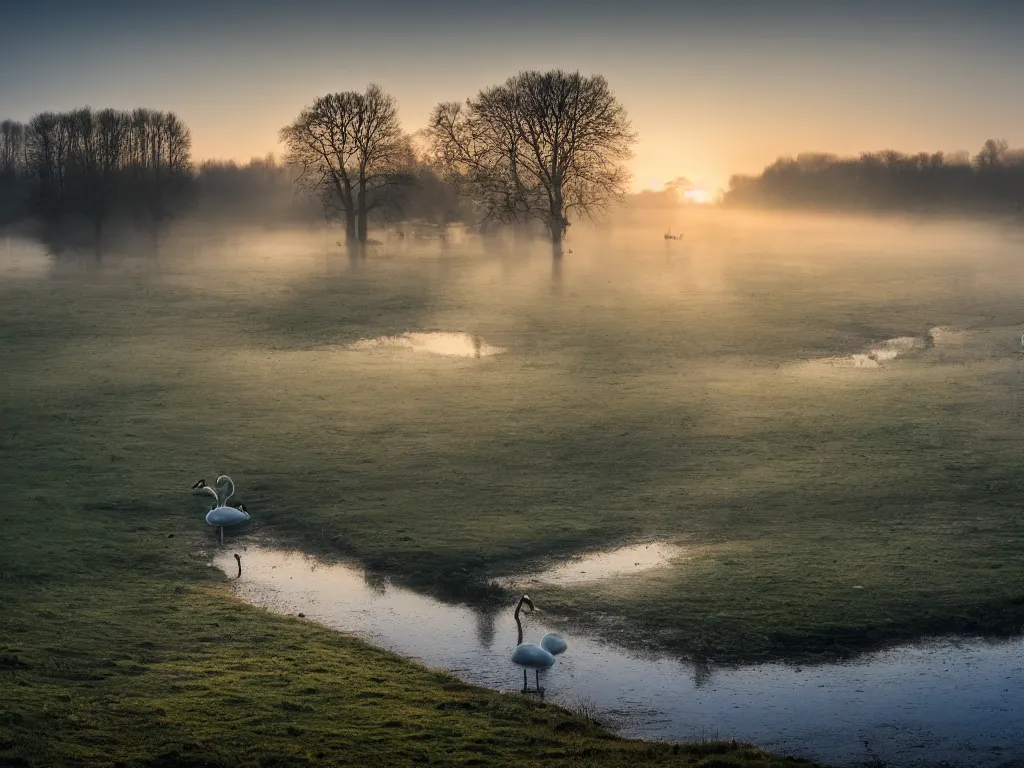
[0,207,1024,765]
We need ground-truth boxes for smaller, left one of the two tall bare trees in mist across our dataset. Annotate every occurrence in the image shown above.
[280,84,412,244]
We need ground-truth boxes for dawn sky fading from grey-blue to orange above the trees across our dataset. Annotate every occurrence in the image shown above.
[0,0,1024,189]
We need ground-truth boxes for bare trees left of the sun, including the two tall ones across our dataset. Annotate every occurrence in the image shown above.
[0,70,635,264]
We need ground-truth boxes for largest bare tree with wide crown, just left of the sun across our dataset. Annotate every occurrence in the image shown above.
[427,70,636,258]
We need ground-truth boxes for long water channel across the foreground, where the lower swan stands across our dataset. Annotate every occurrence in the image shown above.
[214,547,1024,768]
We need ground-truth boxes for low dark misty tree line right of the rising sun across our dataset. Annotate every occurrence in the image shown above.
[724,139,1024,213]
